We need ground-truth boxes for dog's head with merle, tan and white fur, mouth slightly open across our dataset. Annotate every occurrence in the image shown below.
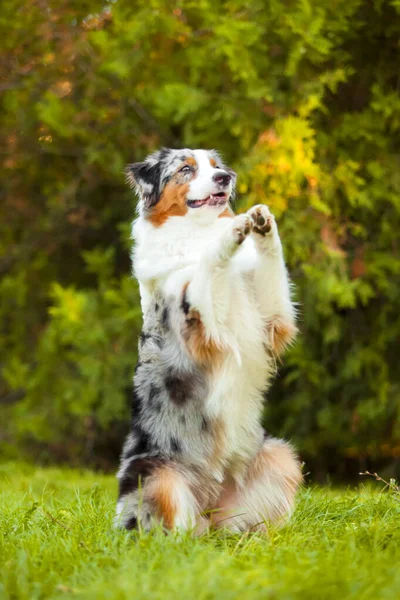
[126,148,236,226]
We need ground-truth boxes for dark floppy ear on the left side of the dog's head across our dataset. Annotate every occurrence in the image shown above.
[125,159,161,210]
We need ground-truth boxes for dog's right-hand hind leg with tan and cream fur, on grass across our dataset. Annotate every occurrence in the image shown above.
[212,438,302,531]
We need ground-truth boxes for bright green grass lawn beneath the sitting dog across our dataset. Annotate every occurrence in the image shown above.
[0,465,400,600]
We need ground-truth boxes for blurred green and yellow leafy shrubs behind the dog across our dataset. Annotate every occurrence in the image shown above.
[0,0,400,478]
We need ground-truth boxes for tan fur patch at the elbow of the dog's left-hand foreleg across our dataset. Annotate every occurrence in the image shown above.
[182,283,222,368]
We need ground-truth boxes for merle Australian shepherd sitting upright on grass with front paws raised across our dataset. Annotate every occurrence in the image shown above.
[117,149,302,533]
